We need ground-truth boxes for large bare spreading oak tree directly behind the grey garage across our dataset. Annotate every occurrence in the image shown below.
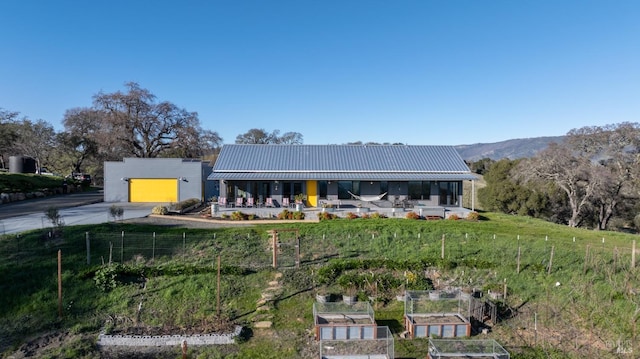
[94,82,219,158]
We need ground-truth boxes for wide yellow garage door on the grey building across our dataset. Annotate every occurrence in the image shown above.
[129,178,178,202]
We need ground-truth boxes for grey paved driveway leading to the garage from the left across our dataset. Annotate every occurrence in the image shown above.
[0,192,155,234]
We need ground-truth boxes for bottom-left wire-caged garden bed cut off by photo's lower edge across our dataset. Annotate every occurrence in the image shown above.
[320,326,394,359]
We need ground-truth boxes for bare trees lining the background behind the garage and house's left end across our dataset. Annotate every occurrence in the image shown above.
[0,82,303,181]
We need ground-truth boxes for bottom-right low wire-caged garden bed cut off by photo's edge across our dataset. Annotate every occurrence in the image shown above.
[427,339,511,359]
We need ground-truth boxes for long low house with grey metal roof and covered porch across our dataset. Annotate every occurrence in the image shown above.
[208,144,476,213]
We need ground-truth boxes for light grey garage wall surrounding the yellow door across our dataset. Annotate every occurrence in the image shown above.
[104,158,206,202]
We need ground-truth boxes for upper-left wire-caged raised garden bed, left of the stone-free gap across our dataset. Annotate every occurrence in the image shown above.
[313,302,376,340]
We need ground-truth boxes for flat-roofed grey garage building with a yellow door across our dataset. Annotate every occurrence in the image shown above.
[104,158,217,203]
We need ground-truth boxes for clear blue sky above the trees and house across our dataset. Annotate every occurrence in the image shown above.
[0,0,640,145]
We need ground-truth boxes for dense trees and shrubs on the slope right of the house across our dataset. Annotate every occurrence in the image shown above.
[470,122,640,230]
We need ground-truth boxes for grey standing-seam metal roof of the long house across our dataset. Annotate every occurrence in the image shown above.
[209,144,476,180]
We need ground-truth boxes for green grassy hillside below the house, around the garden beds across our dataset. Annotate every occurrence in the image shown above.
[0,213,640,358]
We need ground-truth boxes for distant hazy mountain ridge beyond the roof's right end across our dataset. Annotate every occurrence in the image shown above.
[454,136,564,162]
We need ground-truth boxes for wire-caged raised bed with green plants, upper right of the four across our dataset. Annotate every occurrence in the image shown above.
[404,289,471,338]
